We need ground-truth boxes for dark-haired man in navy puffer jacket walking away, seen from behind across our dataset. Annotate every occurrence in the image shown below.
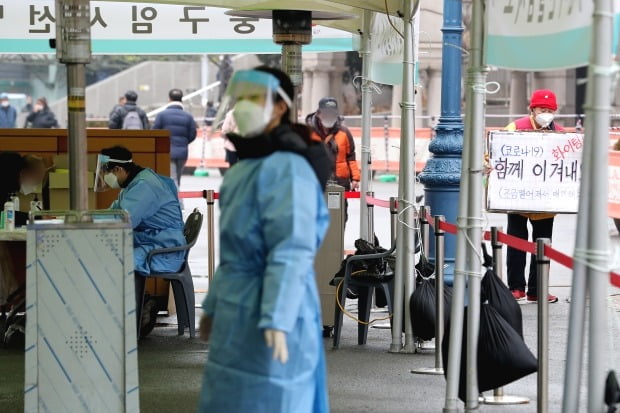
[153,89,196,194]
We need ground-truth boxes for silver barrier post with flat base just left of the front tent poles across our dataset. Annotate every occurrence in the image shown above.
[411,215,446,375]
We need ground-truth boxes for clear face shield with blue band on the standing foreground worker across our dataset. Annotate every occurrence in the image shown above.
[214,70,291,138]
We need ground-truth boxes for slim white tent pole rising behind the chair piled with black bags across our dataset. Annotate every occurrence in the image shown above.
[359,10,374,242]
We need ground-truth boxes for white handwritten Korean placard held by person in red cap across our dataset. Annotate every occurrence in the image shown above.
[487,131,583,213]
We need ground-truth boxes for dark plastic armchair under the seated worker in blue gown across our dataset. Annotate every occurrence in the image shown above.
[136,208,202,338]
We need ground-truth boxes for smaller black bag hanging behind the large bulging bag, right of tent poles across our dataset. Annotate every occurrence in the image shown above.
[480,244,523,338]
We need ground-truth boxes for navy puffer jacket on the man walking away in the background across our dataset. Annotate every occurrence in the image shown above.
[153,103,196,159]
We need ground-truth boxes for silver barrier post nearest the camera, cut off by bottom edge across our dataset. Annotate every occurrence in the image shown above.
[536,238,548,413]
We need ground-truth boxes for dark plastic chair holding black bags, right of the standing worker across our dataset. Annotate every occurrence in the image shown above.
[333,245,396,349]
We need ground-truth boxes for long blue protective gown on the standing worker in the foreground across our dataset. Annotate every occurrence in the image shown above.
[199,152,329,413]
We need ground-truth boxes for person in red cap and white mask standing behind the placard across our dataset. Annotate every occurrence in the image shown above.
[506,89,562,303]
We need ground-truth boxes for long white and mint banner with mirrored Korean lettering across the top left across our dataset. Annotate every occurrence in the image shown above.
[0,0,353,55]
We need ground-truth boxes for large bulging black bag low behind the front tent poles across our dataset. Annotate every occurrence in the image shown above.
[441,304,538,401]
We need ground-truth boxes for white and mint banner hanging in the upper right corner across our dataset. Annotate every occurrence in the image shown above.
[485,0,620,71]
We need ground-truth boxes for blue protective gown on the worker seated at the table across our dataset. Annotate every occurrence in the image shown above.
[110,168,185,274]
